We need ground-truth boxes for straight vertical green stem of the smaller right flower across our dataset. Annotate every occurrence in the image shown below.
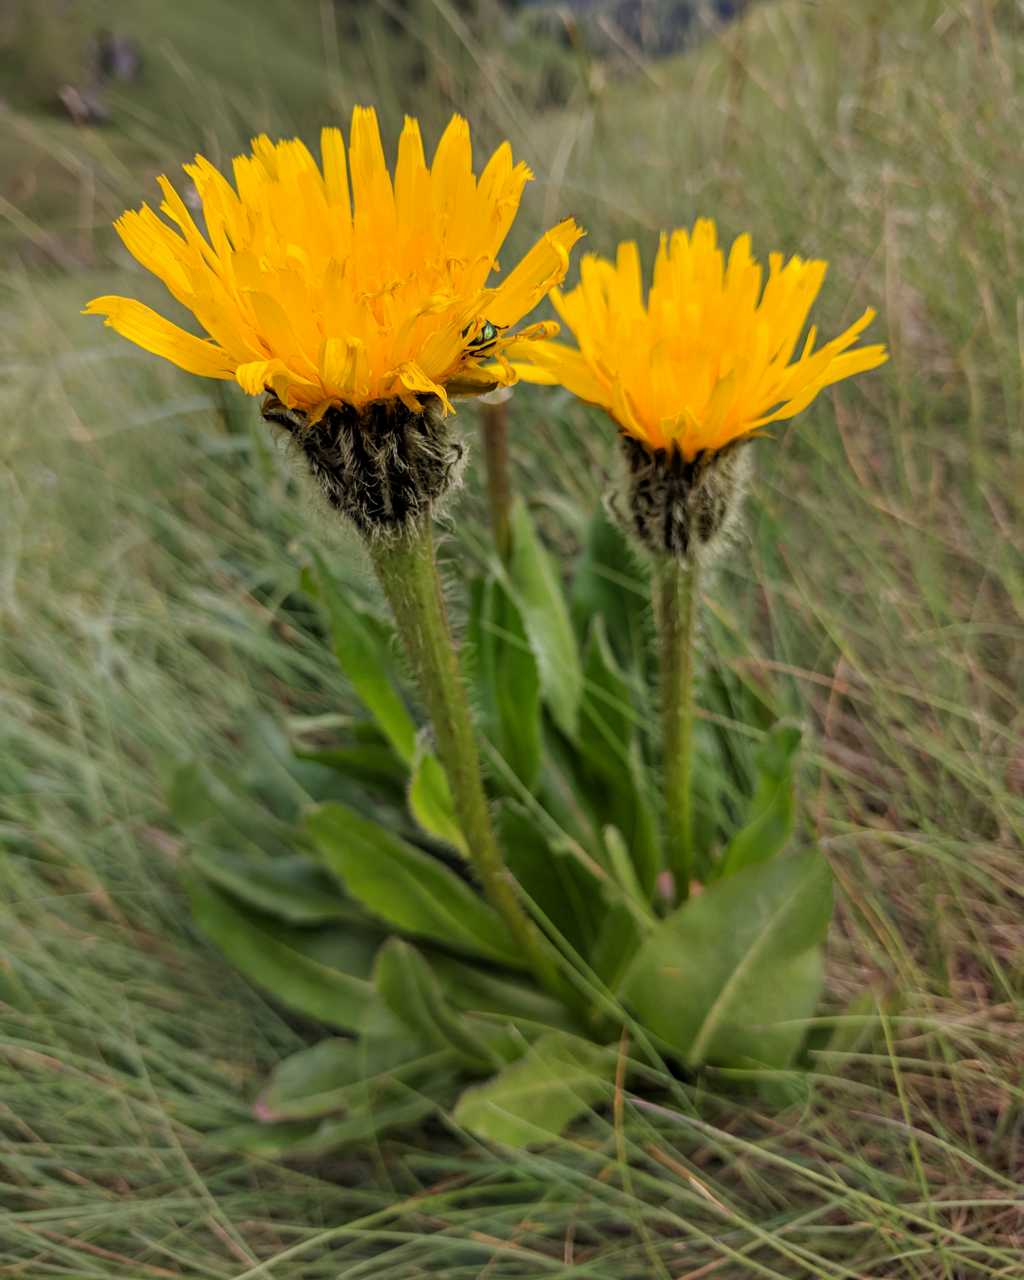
[654,557,699,899]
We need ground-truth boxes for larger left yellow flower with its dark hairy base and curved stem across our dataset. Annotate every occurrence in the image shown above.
[86,108,582,989]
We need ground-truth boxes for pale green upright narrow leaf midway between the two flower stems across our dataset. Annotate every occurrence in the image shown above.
[509,499,584,739]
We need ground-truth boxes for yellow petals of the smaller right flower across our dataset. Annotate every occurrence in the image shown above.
[508,219,887,461]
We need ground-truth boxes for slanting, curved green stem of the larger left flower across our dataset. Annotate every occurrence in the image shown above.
[370,515,561,993]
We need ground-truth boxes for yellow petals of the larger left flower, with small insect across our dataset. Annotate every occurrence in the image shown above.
[86,108,582,422]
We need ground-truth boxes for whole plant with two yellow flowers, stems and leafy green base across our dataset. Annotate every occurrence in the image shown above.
[87,115,886,1155]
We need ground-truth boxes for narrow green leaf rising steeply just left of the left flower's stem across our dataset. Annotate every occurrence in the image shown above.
[307,556,416,764]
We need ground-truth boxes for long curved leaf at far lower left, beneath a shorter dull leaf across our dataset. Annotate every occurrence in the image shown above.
[186,874,376,1030]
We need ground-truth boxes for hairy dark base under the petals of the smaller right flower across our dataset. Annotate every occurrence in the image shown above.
[609,433,750,559]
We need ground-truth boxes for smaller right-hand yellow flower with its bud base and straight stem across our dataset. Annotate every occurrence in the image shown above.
[508,219,887,897]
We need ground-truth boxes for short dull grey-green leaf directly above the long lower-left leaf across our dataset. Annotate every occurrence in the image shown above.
[191,849,361,924]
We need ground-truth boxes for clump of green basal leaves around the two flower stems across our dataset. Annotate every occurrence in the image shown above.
[172,502,832,1156]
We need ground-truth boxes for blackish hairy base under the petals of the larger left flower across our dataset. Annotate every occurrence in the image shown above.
[262,394,465,539]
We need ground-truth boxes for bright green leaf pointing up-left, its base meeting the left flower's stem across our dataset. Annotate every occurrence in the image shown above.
[306,804,522,968]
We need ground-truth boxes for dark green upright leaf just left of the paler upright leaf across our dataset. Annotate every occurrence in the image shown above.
[468,579,543,788]
